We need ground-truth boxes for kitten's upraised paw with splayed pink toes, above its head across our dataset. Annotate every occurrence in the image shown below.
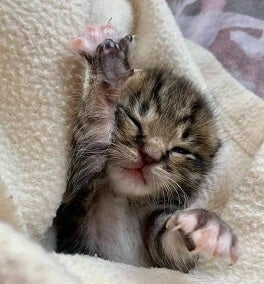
[73,24,134,85]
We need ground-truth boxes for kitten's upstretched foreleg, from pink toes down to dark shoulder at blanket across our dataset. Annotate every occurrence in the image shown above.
[54,26,133,253]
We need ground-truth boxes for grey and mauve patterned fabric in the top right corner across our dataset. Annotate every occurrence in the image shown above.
[167,0,264,98]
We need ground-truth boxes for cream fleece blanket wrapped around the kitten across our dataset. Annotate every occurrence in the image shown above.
[0,0,264,284]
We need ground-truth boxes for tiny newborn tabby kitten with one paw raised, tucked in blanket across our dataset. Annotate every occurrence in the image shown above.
[54,25,239,272]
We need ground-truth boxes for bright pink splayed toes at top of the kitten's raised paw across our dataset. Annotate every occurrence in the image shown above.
[72,24,119,55]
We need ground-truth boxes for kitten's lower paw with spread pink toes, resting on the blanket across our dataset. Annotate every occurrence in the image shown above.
[166,209,239,264]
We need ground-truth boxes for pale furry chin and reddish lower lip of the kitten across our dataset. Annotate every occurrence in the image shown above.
[107,167,154,196]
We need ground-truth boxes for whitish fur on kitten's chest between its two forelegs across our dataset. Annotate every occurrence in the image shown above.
[84,189,146,265]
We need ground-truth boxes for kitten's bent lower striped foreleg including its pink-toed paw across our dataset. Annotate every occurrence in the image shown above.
[147,209,239,272]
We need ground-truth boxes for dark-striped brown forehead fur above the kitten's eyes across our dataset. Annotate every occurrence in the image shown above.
[117,69,218,152]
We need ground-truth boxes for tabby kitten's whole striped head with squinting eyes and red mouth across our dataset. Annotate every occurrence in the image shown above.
[107,70,219,197]
